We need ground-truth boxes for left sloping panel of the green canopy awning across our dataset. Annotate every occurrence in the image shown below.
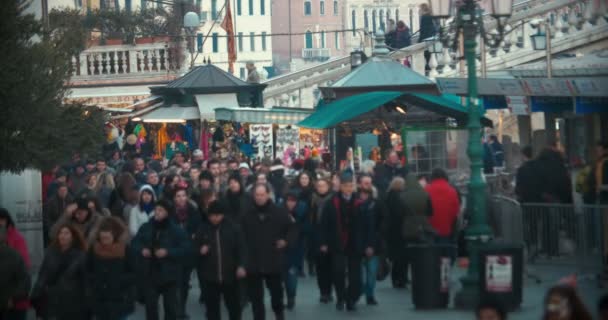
[298,91,403,129]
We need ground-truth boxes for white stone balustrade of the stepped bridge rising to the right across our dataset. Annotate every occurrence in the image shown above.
[264,0,606,107]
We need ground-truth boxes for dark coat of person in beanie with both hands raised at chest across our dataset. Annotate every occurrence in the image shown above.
[131,219,193,285]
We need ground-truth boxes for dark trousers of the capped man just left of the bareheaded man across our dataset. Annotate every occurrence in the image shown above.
[205,281,241,320]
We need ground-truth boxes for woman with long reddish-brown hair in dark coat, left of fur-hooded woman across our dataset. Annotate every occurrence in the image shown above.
[31,223,90,320]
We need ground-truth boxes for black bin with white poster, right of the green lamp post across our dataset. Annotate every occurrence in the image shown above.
[479,242,524,311]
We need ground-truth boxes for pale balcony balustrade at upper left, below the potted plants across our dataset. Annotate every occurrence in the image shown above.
[72,42,180,81]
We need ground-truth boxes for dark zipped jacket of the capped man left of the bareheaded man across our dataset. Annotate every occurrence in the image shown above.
[194,219,246,283]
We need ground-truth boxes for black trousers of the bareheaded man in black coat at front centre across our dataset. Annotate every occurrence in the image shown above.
[247,273,284,320]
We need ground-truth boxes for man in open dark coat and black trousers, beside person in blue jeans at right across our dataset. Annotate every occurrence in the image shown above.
[320,170,374,311]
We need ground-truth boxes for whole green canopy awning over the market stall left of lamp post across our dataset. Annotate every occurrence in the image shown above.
[298,91,492,131]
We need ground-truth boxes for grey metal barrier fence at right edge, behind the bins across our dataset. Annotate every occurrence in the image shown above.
[489,196,608,275]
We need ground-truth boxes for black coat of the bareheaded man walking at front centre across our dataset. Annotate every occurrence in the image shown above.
[241,201,296,274]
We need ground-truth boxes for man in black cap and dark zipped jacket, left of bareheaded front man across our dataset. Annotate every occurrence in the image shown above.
[194,201,247,320]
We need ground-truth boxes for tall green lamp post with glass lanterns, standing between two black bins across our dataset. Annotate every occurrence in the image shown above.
[429,0,513,309]
